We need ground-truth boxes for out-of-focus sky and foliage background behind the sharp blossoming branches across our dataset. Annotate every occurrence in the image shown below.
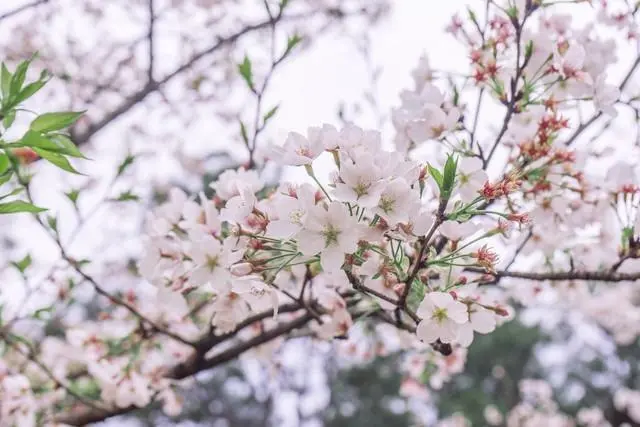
[0,0,640,427]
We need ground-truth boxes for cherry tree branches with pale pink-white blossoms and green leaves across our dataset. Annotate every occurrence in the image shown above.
[0,0,640,426]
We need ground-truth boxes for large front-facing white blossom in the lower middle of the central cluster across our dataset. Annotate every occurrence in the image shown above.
[297,202,360,272]
